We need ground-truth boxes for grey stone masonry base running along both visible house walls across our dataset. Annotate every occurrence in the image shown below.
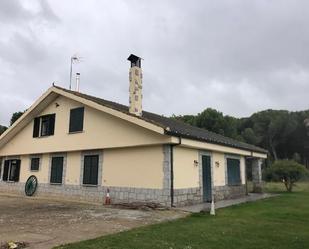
[0,182,246,207]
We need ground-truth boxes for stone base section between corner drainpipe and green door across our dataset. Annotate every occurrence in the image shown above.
[174,187,203,207]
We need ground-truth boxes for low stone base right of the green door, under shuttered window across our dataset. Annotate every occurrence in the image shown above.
[213,185,246,201]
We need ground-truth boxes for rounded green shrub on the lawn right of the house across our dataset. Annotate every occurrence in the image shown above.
[266,160,309,192]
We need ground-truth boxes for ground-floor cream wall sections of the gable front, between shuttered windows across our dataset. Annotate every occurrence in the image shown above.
[3,146,164,189]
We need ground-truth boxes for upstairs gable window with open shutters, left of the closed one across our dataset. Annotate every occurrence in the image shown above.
[33,114,56,137]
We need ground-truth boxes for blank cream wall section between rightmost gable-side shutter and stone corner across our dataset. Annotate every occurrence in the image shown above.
[102,146,164,189]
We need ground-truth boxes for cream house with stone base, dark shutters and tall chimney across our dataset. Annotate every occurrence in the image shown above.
[0,55,267,206]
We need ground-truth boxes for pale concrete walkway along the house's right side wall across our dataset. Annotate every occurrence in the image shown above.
[176,193,278,213]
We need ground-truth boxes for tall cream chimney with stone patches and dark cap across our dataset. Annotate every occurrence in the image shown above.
[128,54,143,116]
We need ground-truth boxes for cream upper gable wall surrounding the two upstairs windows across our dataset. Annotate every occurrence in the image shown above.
[0,97,170,156]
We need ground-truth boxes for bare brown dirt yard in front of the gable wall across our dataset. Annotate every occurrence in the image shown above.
[0,195,186,249]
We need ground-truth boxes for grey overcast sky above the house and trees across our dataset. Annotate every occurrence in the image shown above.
[0,0,309,125]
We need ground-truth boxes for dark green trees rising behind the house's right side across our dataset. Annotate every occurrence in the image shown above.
[173,108,309,166]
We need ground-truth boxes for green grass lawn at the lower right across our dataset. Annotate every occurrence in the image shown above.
[58,184,309,249]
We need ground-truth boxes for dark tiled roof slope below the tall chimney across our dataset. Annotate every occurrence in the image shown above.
[55,86,267,153]
